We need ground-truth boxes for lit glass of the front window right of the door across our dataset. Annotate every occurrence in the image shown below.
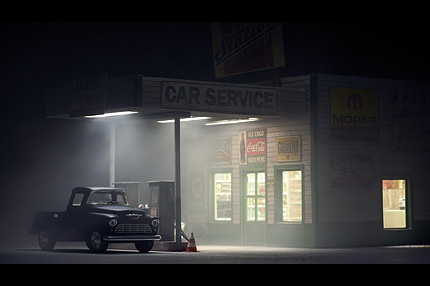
[282,170,302,223]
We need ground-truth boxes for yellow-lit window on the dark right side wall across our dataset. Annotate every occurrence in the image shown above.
[382,180,406,228]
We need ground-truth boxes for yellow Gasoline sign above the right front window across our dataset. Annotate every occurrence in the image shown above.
[276,136,301,162]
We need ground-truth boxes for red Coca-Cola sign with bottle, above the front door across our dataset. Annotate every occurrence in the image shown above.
[239,128,267,165]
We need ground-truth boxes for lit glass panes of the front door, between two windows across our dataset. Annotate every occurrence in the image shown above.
[246,173,266,221]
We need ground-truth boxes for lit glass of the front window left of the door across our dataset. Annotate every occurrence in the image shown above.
[214,173,232,221]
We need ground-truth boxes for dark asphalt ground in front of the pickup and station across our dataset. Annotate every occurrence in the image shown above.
[0,243,430,264]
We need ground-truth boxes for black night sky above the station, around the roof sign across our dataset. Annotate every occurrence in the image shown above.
[0,21,430,117]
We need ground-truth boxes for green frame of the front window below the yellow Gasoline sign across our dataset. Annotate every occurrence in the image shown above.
[274,165,305,225]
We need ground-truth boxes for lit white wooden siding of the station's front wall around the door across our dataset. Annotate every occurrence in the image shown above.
[142,77,313,228]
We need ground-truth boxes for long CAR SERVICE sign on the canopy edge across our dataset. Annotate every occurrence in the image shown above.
[161,81,276,115]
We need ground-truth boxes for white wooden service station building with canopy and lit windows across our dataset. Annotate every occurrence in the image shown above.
[47,74,430,247]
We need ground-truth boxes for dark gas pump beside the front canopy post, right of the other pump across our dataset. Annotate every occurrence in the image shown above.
[146,181,175,241]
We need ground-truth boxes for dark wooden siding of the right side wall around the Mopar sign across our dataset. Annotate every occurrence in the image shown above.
[317,74,430,225]
